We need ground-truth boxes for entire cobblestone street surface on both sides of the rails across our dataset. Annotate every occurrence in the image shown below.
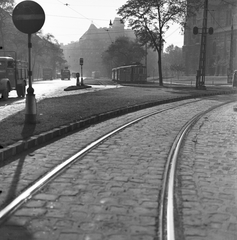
[0,96,237,240]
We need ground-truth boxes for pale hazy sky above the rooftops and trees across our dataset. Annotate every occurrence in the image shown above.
[15,0,183,46]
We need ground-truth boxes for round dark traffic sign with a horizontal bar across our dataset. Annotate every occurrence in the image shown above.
[12,1,45,34]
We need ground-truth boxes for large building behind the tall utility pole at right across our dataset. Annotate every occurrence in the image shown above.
[183,0,237,76]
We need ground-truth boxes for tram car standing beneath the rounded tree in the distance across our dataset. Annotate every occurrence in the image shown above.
[112,65,147,83]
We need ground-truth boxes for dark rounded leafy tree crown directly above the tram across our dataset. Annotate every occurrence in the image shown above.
[102,37,145,69]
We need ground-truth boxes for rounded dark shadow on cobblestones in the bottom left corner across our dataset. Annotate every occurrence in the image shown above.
[0,222,33,240]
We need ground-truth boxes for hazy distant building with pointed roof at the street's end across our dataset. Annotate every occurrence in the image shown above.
[63,18,135,77]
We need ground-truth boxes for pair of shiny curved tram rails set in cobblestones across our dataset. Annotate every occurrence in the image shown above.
[0,95,236,240]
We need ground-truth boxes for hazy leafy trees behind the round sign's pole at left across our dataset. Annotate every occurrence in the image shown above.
[0,0,65,79]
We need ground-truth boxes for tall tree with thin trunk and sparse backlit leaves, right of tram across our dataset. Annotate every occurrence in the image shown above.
[118,0,201,86]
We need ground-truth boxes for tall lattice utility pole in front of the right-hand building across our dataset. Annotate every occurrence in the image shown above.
[196,0,208,89]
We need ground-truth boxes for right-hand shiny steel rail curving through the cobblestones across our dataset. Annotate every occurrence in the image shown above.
[158,101,233,240]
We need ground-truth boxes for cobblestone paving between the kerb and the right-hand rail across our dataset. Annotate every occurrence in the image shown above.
[0,96,236,240]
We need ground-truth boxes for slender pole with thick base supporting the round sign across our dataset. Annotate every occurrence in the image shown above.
[25,34,36,124]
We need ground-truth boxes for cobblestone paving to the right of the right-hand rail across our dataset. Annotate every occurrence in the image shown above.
[178,100,237,240]
